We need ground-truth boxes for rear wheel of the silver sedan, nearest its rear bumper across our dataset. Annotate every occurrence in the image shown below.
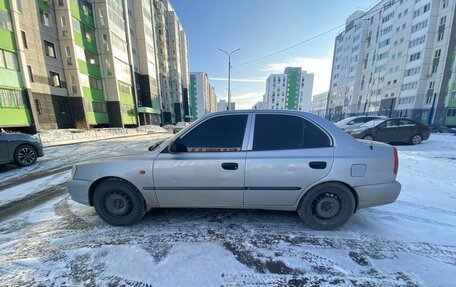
[297,182,356,230]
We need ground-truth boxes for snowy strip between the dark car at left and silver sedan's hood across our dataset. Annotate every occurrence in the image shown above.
[0,133,171,186]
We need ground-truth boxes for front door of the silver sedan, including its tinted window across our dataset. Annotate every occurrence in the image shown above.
[154,113,249,207]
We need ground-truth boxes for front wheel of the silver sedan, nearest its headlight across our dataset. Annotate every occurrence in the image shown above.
[93,178,146,226]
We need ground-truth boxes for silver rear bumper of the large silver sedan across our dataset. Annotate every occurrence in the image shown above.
[354,181,401,208]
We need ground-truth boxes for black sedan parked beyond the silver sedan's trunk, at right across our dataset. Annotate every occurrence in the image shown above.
[346,118,431,144]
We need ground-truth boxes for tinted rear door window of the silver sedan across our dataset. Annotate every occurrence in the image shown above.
[253,115,331,151]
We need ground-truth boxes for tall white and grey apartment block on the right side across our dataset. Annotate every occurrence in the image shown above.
[327,0,456,125]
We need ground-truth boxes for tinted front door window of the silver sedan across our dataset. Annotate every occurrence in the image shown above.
[179,115,247,152]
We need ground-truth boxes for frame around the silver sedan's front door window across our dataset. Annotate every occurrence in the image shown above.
[168,112,253,154]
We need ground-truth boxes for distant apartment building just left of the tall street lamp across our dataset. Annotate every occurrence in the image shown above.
[189,72,217,119]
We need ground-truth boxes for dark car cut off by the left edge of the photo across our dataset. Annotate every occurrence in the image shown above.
[0,133,44,166]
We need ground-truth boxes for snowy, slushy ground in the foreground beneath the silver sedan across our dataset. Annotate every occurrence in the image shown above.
[0,135,456,286]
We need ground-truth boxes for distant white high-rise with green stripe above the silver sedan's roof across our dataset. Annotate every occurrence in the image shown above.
[264,67,314,112]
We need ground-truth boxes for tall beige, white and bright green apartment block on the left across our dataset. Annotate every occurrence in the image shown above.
[0,0,189,131]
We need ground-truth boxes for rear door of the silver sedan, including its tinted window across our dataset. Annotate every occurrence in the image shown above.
[244,113,334,206]
